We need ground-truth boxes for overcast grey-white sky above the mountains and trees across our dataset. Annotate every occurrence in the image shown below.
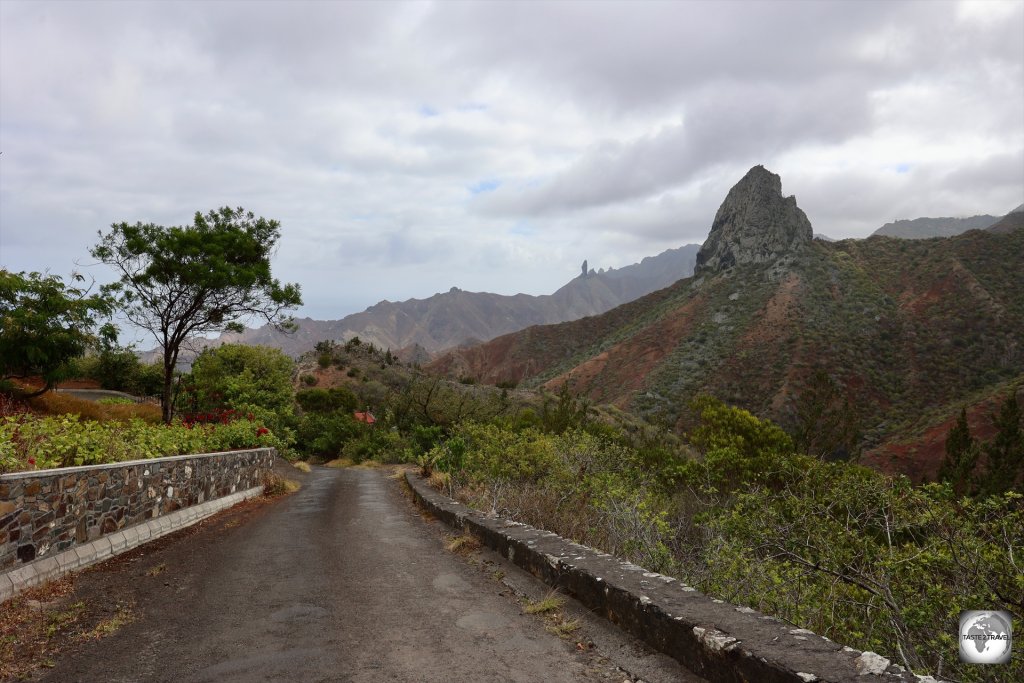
[0,0,1024,318]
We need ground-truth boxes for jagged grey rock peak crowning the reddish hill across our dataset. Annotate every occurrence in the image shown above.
[695,166,814,272]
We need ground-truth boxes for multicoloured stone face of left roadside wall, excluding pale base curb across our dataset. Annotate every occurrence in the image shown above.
[0,449,274,572]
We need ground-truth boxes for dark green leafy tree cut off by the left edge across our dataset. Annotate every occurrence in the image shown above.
[0,270,116,395]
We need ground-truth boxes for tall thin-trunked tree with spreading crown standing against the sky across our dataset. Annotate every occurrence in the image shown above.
[91,207,302,423]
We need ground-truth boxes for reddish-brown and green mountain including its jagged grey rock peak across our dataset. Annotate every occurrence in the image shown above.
[428,167,1024,476]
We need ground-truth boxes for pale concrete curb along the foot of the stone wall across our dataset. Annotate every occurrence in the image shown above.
[0,486,263,602]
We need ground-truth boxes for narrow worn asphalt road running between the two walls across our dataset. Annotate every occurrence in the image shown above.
[42,468,701,683]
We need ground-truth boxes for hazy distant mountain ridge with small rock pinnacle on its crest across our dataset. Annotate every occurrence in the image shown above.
[212,245,699,359]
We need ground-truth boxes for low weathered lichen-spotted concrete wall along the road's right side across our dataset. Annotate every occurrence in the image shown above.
[406,472,935,683]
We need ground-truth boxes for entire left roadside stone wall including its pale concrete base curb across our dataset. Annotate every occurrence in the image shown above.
[0,449,274,600]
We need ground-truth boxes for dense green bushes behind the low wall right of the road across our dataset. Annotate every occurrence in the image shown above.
[425,398,1024,681]
